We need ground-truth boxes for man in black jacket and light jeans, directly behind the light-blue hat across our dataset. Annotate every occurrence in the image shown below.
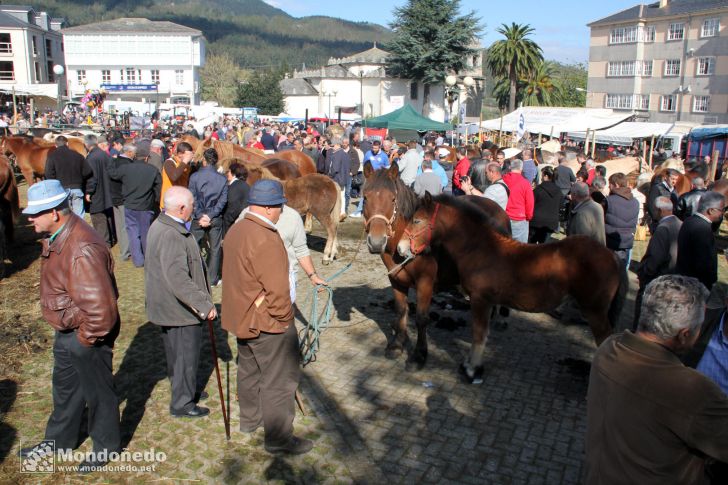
[45,135,94,218]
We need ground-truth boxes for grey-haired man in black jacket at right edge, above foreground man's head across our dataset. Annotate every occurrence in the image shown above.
[675,191,725,290]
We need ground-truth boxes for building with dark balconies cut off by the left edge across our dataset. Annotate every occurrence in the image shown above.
[0,5,64,87]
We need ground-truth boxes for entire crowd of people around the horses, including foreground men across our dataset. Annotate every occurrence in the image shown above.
[11,114,728,483]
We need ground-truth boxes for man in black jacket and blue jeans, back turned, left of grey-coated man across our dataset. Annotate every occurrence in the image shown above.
[109,143,162,268]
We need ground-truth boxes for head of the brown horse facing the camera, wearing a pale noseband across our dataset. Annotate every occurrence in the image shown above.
[362,162,399,254]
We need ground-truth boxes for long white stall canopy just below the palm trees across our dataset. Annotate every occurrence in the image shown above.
[480,106,633,136]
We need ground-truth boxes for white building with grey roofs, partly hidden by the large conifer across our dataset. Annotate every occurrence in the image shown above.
[281,44,482,121]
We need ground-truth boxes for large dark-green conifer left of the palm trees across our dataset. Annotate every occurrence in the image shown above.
[385,0,480,116]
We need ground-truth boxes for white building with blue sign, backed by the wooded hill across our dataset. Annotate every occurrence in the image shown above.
[63,18,205,104]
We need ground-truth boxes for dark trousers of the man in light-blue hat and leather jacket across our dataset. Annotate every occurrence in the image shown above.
[45,331,121,452]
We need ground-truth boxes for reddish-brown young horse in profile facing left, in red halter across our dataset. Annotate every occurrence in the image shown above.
[397,193,625,383]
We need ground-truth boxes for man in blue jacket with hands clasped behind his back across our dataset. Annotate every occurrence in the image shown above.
[189,148,228,286]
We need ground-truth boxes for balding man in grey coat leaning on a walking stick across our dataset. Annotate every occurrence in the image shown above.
[144,187,217,418]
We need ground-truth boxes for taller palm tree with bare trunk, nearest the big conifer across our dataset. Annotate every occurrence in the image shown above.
[488,22,543,111]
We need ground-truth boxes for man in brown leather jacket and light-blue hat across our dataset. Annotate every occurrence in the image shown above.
[20,179,121,472]
